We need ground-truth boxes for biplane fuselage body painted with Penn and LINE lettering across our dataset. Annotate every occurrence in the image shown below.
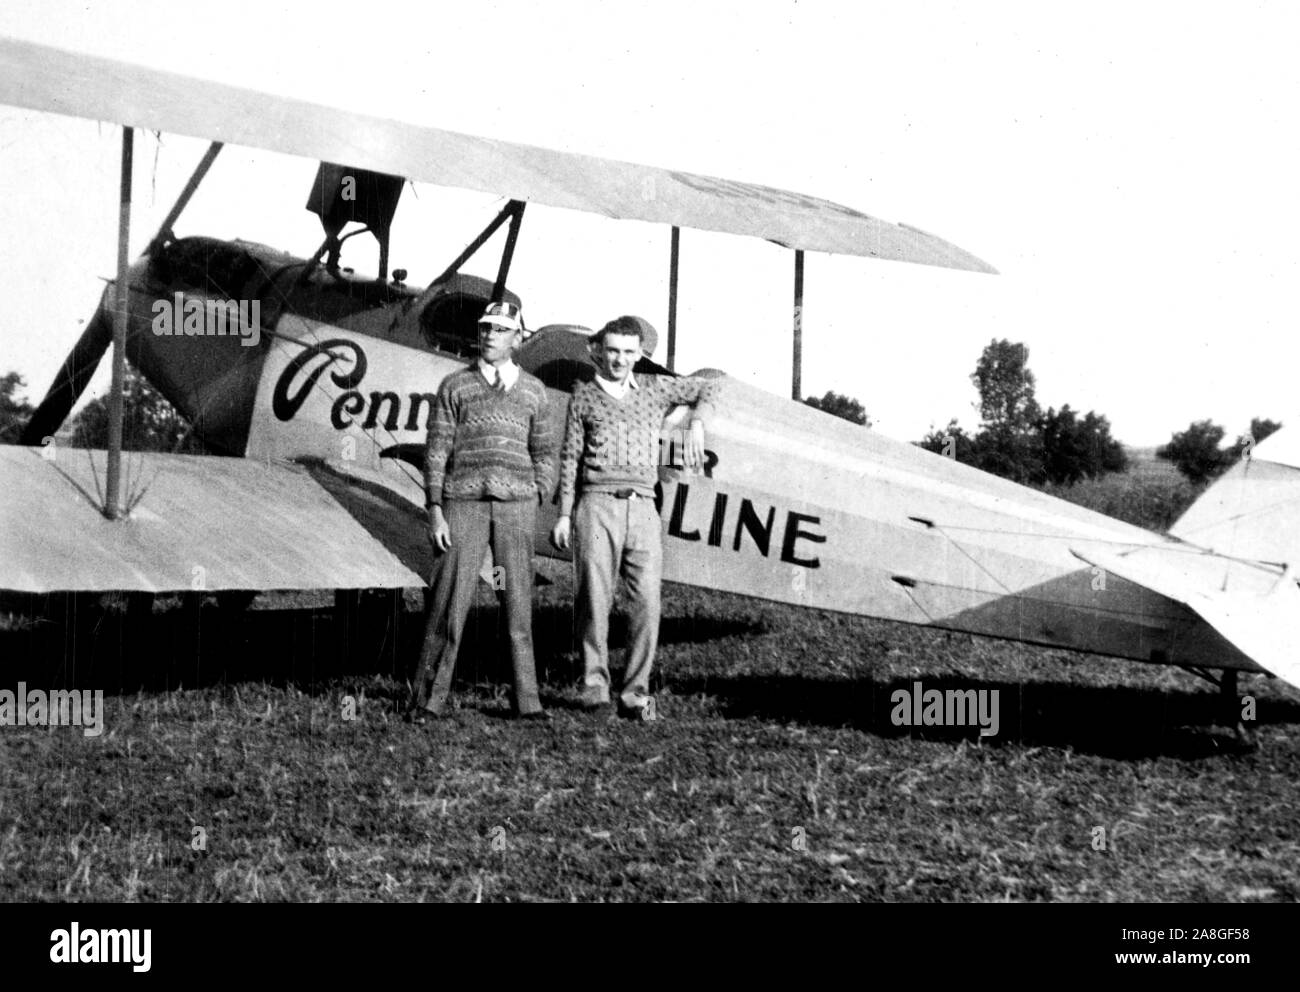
[109,239,1257,671]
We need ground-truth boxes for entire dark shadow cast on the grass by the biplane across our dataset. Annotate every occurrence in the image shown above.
[0,594,1300,758]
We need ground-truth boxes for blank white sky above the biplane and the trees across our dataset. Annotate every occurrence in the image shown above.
[0,0,1300,445]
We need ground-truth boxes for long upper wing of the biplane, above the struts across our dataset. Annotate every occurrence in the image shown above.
[0,39,995,272]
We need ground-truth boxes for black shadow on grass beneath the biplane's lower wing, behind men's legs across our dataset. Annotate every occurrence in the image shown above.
[0,593,764,693]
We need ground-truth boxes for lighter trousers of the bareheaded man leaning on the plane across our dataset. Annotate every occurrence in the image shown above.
[573,493,663,709]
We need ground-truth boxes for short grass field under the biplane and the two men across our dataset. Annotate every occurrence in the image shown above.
[0,455,1300,901]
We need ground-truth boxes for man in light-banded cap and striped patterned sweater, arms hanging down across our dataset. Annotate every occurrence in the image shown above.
[411,303,555,723]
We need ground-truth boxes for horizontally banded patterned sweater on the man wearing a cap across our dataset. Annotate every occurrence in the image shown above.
[424,365,555,506]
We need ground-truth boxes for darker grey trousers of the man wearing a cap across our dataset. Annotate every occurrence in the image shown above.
[415,499,542,712]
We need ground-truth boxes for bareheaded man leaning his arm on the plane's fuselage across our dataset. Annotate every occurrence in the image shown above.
[551,317,714,720]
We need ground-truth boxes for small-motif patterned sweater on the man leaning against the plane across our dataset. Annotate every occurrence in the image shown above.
[560,376,718,516]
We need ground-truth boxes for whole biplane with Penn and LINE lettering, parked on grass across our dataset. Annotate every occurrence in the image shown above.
[0,32,1300,738]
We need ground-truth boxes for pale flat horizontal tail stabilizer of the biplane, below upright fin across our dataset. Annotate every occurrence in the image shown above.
[1070,547,1300,688]
